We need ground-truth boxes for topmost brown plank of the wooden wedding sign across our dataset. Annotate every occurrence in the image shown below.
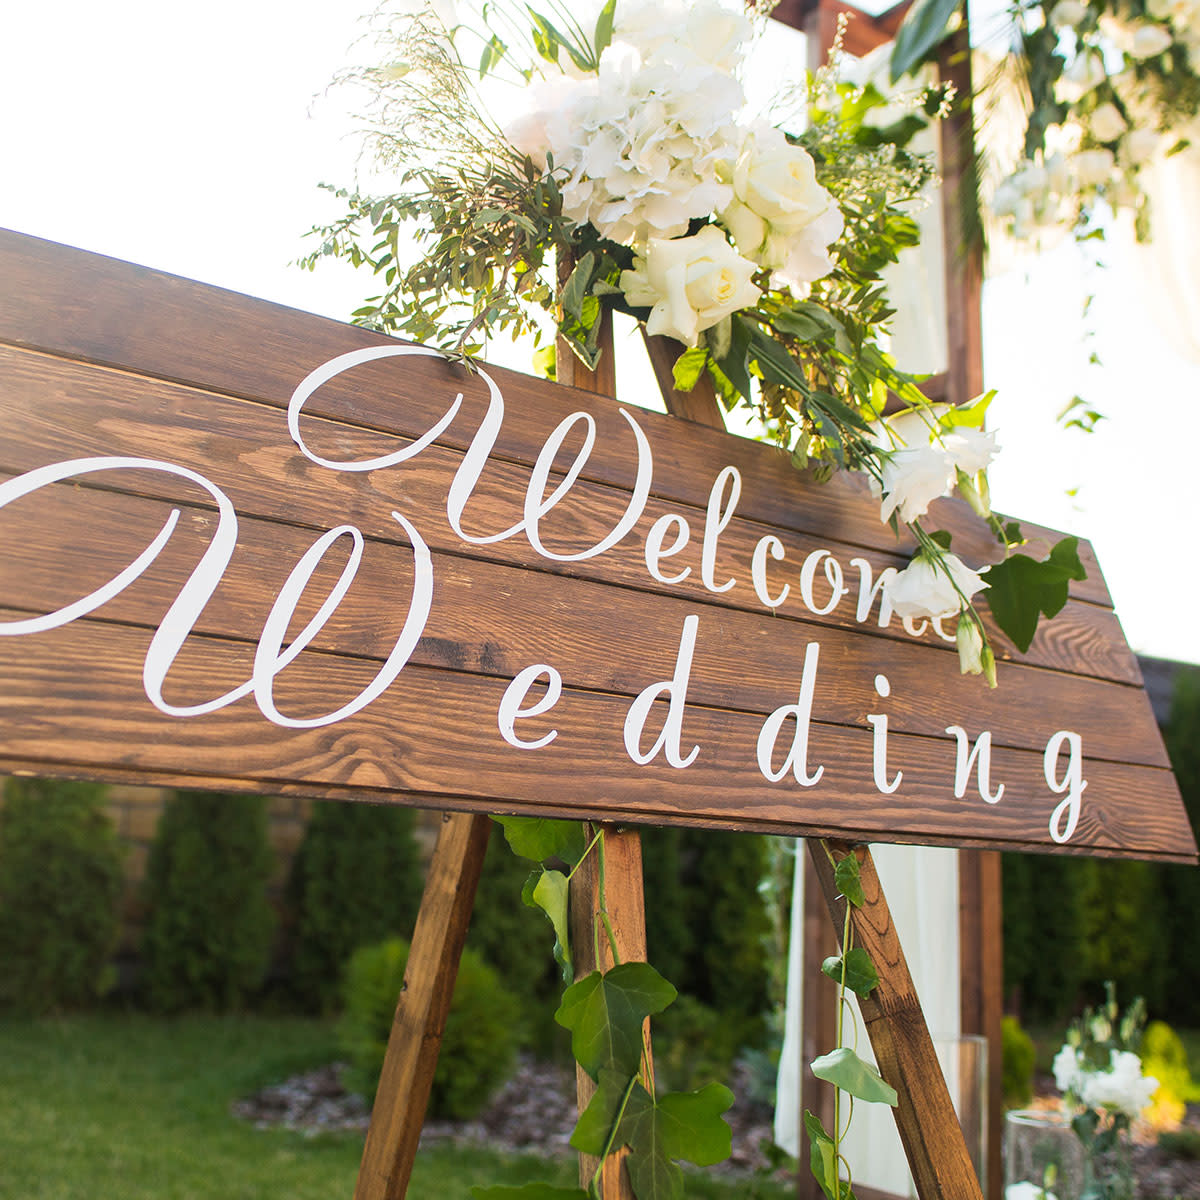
[0,232,1110,604]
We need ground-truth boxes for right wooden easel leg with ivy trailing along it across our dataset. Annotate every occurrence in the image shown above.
[809,840,983,1200]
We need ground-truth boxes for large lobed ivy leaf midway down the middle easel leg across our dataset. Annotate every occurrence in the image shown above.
[554,962,677,1079]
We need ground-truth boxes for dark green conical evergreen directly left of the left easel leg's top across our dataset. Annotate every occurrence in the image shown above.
[288,800,421,1013]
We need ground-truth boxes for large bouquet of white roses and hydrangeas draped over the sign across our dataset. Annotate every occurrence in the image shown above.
[305,0,1084,685]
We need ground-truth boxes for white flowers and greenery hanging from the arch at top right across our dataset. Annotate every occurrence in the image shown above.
[892,0,1200,241]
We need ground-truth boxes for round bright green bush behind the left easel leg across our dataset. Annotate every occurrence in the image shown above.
[337,937,518,1120]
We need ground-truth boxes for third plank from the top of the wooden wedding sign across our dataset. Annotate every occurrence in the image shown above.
[0,475,1168,767]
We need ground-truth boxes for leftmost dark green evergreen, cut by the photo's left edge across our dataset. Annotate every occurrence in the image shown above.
[0,779,125,1013]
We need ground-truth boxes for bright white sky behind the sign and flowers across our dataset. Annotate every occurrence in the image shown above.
[0,0,1200,662]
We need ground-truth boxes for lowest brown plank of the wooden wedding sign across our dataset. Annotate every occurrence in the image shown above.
[0,611,1194,860]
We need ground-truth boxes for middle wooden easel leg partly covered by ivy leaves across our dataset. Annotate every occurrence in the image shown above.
[570,826,653,1200]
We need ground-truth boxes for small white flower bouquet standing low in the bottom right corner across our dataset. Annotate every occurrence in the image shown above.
[1054,983,1158,1200]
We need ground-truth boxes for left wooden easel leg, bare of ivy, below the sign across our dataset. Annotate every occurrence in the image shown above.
[354,812,492,1200]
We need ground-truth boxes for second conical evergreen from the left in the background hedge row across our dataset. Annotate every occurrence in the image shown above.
[142,792,275,1013]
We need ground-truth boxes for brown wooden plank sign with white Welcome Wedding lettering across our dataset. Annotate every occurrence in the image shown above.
[0,226,1195,860]
